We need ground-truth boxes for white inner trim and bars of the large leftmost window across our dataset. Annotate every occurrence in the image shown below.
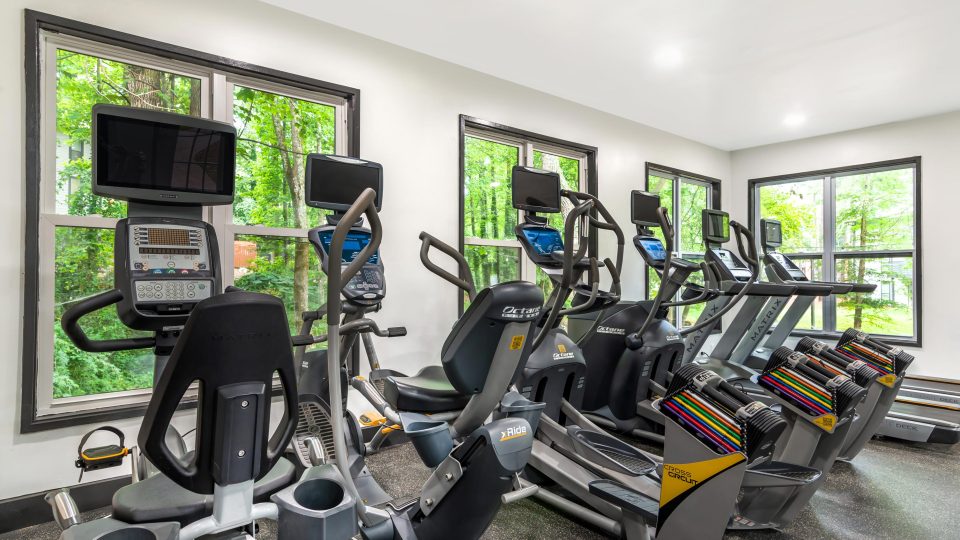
[36,31,348,419]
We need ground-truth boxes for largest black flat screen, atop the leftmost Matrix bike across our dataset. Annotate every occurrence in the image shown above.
[91,105,237,205]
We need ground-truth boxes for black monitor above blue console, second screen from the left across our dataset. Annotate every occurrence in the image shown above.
[306,154,383,212]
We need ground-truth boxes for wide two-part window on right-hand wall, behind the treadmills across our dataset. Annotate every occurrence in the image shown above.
[750,158,920,343]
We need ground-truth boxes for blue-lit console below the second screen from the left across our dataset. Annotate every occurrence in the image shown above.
[310,226,387,306]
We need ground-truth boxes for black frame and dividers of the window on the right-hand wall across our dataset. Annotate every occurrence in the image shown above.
[747,156,923,347]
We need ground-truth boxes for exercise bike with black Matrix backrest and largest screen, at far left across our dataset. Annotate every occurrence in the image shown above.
[49,105,353,540]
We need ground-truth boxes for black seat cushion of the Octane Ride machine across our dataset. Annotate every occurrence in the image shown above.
[383,366,470,413]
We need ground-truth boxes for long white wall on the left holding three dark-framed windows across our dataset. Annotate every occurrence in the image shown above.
[0,0,730,499]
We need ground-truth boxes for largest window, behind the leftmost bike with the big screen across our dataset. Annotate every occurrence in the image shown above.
[21,13,356,431]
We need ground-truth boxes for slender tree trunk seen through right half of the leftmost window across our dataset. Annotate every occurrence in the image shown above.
[273,98,311,316]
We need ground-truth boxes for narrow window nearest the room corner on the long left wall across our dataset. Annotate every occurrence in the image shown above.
[646,163,720,328]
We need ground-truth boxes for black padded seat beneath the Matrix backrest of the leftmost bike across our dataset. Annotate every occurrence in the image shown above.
[113,454,296,525]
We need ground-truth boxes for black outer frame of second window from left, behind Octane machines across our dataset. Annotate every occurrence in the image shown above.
[457,114,599,315]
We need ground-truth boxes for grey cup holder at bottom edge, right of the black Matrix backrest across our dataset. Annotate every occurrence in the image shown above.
[270,463,357,540]
